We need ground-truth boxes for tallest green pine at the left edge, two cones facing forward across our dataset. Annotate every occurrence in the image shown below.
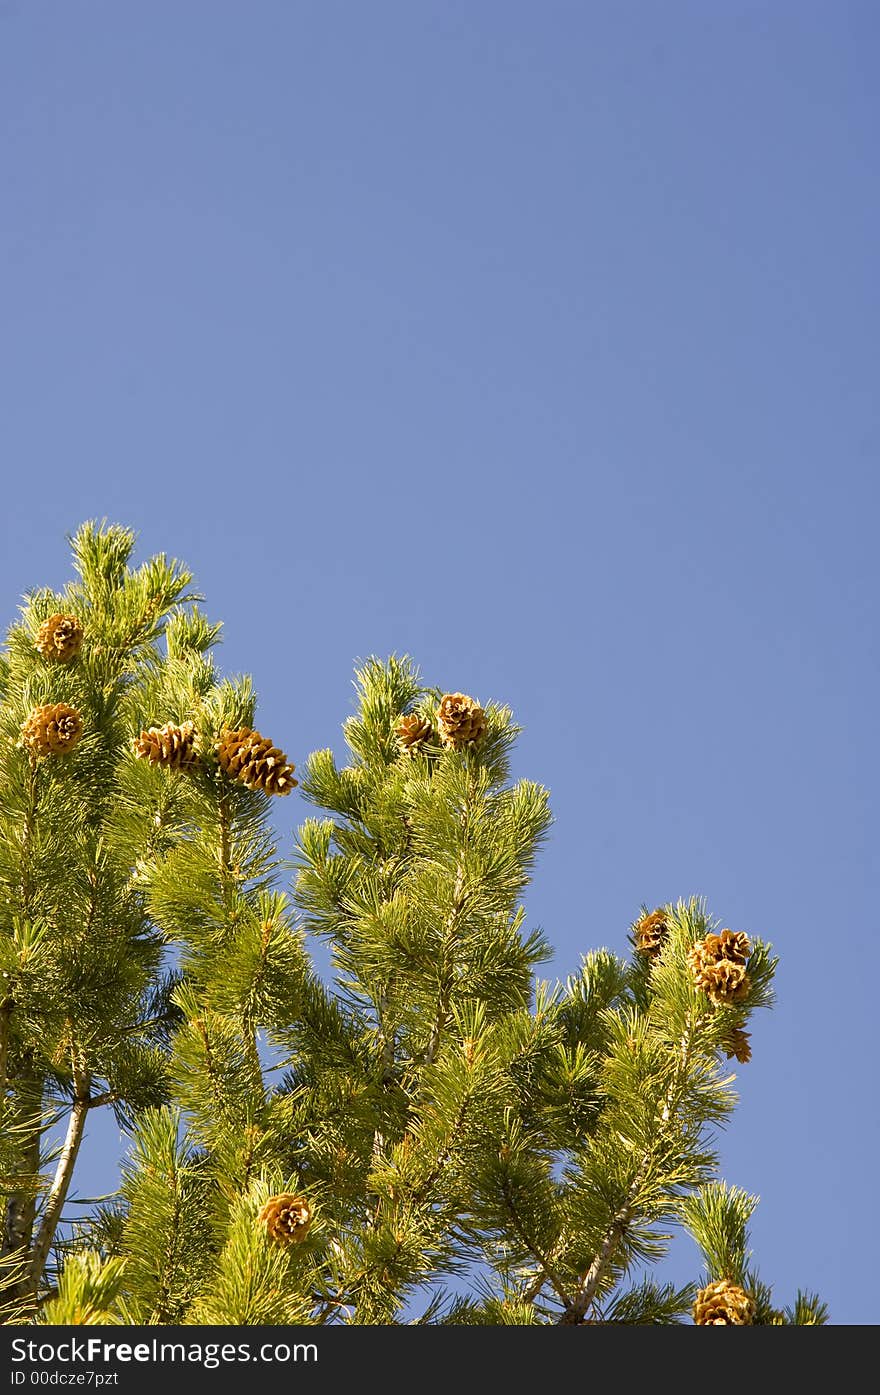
[0,523,215,1315]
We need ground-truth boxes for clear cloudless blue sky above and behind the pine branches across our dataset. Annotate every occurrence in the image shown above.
[0,0,880,1324]
